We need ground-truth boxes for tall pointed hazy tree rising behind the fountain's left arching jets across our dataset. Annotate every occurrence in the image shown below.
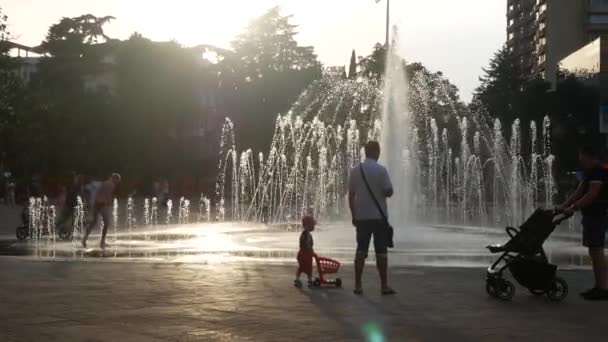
[222,7,321,149]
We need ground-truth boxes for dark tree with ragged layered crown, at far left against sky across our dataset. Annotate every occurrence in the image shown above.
[21,15,117,174]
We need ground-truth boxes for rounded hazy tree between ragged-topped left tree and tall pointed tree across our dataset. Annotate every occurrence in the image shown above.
[112,35,205,176]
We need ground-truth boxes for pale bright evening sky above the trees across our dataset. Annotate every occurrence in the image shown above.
[0,0,507,101]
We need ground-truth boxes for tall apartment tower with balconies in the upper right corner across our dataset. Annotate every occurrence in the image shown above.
[507,0,608,85]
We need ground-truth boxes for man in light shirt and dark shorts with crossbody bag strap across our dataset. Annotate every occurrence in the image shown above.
[348,141,395,295]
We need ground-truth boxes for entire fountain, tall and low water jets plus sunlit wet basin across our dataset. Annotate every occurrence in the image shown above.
[10,27,582,265]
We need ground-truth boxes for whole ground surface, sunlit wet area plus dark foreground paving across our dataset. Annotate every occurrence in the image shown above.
[0,207,608,342]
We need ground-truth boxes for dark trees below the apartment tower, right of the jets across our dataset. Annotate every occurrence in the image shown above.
[470,48,604,174]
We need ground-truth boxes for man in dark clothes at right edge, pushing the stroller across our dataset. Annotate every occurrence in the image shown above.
[560,146,608,300]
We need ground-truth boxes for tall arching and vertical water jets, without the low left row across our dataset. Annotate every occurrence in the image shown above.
[215,52,556,228]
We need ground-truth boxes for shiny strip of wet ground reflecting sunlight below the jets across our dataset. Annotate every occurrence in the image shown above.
[0,223,589,267]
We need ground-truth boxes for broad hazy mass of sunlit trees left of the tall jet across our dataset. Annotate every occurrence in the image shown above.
[0,8,321,186]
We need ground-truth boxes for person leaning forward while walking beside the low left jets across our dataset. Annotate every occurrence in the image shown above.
[82,173,121,248]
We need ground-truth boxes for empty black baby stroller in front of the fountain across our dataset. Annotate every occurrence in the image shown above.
[486,209,570,302]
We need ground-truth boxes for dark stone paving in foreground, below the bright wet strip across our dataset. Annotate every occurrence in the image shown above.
[0,257,608,342]
